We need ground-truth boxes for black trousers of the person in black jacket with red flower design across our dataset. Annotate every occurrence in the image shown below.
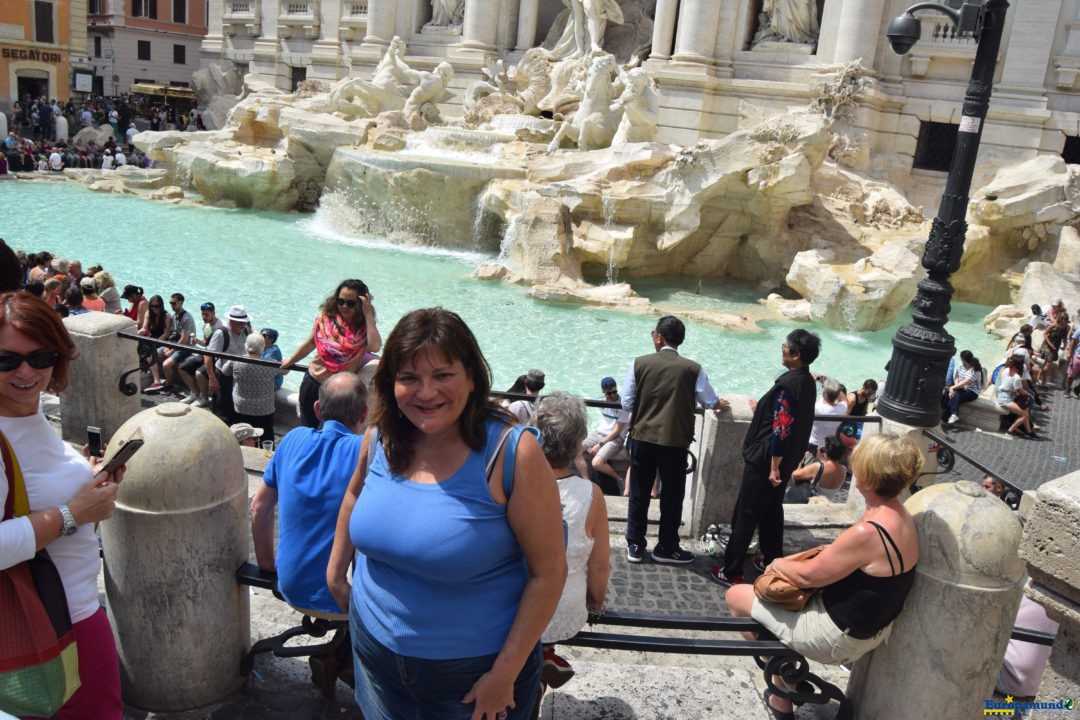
[724,464,787,578]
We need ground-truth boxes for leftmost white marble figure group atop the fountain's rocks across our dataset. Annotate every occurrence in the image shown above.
[329,36,424,120]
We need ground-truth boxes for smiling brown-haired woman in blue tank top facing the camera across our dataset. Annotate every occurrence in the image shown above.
[326,308,566,720]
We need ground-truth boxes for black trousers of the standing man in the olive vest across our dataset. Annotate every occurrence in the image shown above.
[626,439,687,553]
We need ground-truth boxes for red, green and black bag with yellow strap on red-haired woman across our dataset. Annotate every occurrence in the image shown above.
[0,433,79,717]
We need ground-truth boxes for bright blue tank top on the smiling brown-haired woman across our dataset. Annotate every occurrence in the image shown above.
[349,421,528,660]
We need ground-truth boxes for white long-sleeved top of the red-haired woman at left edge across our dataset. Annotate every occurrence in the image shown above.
[0,412,102,623]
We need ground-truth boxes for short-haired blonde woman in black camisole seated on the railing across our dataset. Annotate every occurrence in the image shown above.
[727,434,923,720]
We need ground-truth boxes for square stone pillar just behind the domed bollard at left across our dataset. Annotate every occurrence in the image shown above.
[60,312,139,445]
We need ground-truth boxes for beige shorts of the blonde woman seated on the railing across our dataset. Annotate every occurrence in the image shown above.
[750,593,892,665]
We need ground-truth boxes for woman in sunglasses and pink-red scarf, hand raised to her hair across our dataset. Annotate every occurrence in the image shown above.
[281,280,382,427]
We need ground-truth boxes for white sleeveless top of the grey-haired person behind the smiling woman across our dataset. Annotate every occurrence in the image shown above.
[541,475,593,644]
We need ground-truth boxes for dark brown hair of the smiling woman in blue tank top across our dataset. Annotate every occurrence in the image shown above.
[372,308,514,473]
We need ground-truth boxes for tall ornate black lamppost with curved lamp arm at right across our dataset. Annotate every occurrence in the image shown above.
[878,0,1009,427]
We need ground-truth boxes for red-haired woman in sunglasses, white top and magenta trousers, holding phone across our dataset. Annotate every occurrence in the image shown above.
[0,293,123,720]
